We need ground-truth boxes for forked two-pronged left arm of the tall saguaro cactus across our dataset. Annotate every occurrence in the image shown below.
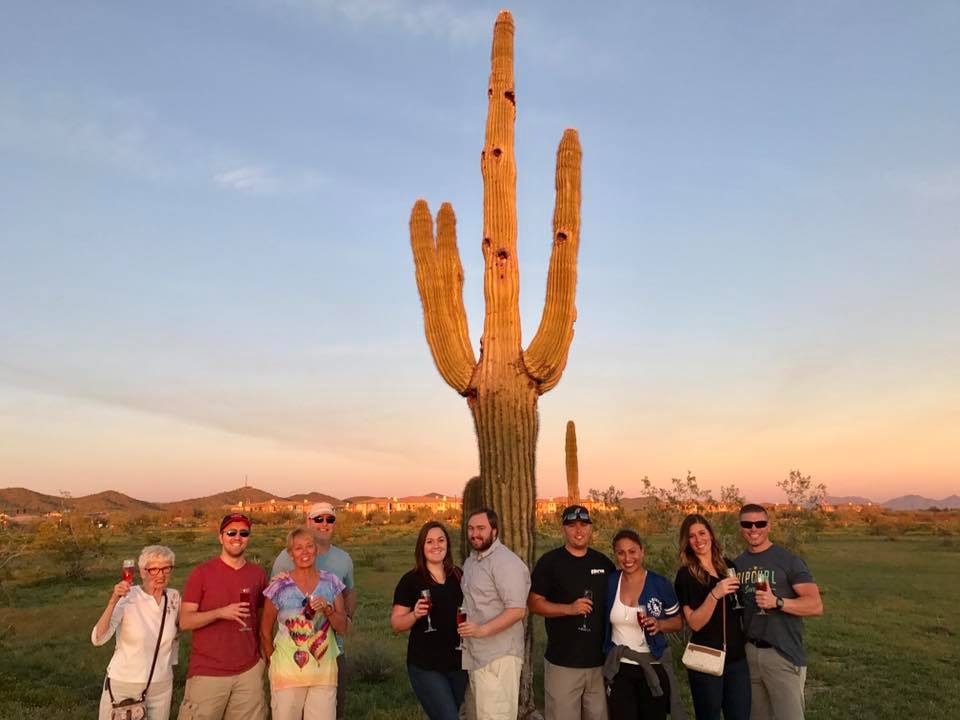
[410,200,476,394]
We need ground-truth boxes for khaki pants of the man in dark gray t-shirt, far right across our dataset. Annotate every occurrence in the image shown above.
[747,643,807,720]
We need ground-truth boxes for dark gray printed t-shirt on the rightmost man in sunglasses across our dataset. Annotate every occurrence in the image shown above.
[734,545,813,667]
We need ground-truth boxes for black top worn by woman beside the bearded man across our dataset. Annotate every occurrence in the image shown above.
[393,570,463,672]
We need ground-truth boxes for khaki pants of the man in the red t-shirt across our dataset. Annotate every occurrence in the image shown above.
[177,660,267,720]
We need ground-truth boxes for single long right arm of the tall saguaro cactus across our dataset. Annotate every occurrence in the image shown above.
[523,129,582,394]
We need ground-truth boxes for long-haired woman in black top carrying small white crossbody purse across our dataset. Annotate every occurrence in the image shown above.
[674,514,750,720]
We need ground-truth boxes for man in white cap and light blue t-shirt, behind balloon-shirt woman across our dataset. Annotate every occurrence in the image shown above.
[270,503,357,720]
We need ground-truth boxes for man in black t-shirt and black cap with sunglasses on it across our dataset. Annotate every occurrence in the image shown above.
[527,505,615,720]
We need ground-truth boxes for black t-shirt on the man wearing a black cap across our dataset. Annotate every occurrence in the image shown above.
[530,547,615,668]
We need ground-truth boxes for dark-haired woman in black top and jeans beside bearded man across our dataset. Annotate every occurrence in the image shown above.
[390,521,467,720]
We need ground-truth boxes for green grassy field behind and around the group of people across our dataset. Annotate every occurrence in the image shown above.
[0,527,960,720]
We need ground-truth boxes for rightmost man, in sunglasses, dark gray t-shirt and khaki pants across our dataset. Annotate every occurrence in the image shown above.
[735,504,823,720]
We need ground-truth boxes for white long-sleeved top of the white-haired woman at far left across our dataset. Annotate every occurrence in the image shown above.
[90,585,180,683]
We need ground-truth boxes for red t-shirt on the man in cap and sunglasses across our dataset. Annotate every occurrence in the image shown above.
[182,557,267,678]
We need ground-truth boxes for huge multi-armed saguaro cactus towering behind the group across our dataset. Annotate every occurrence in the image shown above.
[410,11,581,716]
